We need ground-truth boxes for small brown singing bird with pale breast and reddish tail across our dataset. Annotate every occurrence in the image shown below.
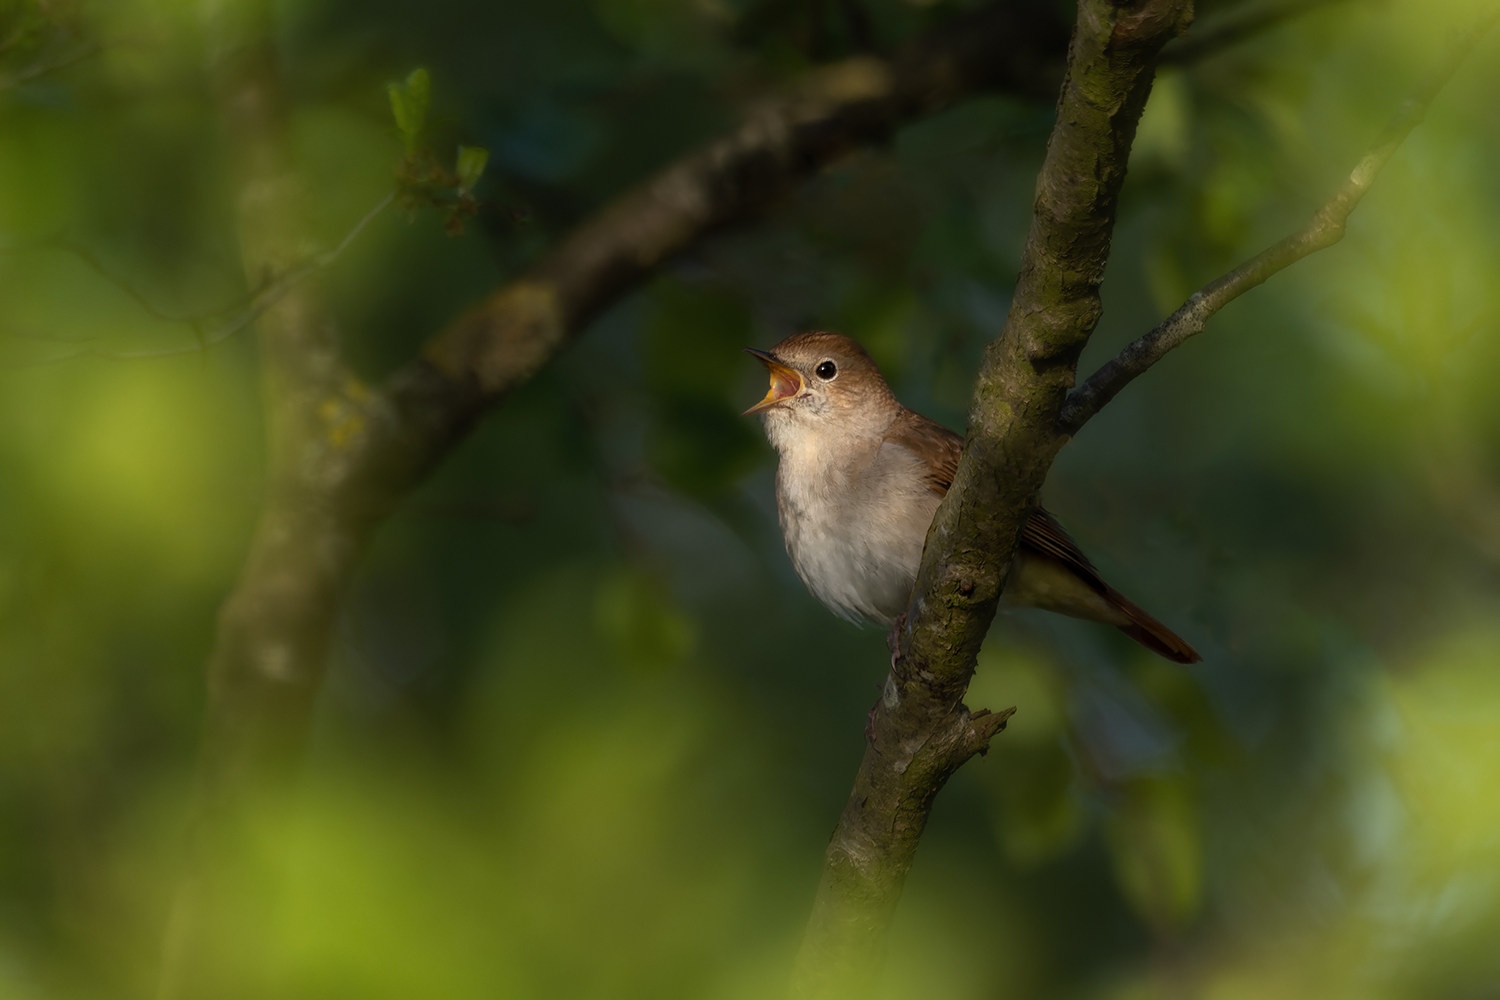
[744,330,1202,663]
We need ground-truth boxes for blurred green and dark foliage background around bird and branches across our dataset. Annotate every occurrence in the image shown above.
[0,0,1500,1000]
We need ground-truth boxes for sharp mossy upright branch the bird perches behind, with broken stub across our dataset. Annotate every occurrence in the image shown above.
[792,0,1193,997]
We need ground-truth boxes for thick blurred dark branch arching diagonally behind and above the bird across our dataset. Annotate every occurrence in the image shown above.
[348,0,1314,515]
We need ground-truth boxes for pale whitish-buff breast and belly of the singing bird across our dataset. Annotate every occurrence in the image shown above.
[776,441,939,624]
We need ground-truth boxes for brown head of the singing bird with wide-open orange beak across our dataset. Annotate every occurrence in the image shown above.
[746,331,897,433]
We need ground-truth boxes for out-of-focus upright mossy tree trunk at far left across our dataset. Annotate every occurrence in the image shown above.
[161,0,371,999]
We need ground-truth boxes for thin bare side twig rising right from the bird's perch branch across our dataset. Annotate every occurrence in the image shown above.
[1058,3,1500,435]
